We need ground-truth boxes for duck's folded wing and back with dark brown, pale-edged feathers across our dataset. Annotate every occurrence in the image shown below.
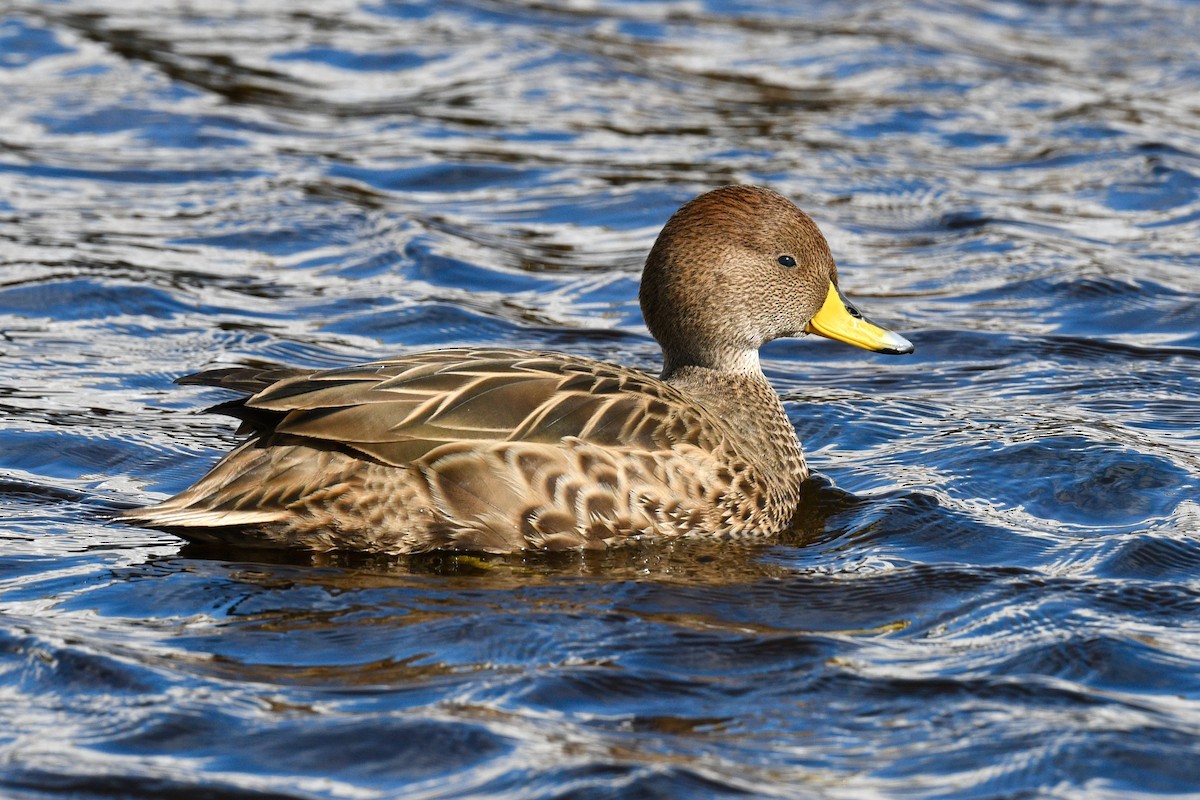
[177,349,724,464]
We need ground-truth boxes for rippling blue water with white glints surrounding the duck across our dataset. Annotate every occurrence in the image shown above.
[0,0,1200,799]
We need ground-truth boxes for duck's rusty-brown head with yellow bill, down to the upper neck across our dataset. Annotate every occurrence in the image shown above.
[638,186,912,374]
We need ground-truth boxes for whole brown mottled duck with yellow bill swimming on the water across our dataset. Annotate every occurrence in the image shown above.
[126,186,912,553]
